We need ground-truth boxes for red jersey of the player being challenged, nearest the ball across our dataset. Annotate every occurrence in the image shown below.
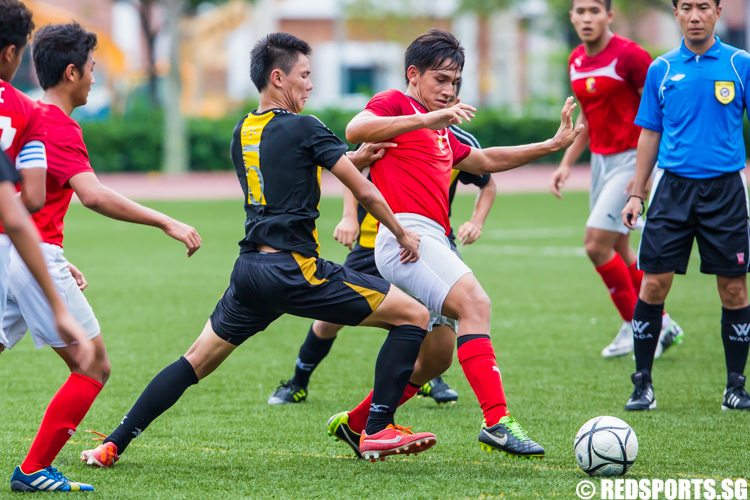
[365,90,471,234]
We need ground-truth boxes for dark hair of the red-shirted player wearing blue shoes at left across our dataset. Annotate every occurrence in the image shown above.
[32,23,97,90]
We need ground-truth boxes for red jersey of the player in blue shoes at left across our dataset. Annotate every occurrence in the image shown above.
[32,102,94,247]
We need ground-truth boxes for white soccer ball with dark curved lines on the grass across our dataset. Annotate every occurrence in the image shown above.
[573,417,638,476]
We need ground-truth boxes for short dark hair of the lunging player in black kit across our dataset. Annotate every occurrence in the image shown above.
[250,33,312,92]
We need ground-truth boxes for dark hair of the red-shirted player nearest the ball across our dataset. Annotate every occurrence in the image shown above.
[404,28,464,84]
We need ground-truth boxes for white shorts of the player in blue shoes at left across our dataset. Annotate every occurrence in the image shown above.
[3,243,100,349]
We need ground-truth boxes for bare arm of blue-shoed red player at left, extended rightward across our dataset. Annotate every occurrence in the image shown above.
[68,172,201,257]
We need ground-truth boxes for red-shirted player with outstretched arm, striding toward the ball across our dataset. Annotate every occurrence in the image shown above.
[329,29,583,458]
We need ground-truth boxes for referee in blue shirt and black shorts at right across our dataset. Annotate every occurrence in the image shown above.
[622,0,750,410]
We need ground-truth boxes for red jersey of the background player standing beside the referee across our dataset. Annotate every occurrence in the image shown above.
[569,35,651,155]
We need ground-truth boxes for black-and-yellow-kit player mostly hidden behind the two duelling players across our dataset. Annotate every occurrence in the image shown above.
[268,80,497,405]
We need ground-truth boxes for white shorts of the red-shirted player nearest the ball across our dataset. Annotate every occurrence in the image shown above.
[375,214,471,332]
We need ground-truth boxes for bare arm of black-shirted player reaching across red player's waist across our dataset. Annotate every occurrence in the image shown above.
[331,155,419,264]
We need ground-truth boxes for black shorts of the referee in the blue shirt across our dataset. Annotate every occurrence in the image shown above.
[638,171,750,277]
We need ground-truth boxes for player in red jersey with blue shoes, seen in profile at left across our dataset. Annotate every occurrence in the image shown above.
[3,23,201,491]
